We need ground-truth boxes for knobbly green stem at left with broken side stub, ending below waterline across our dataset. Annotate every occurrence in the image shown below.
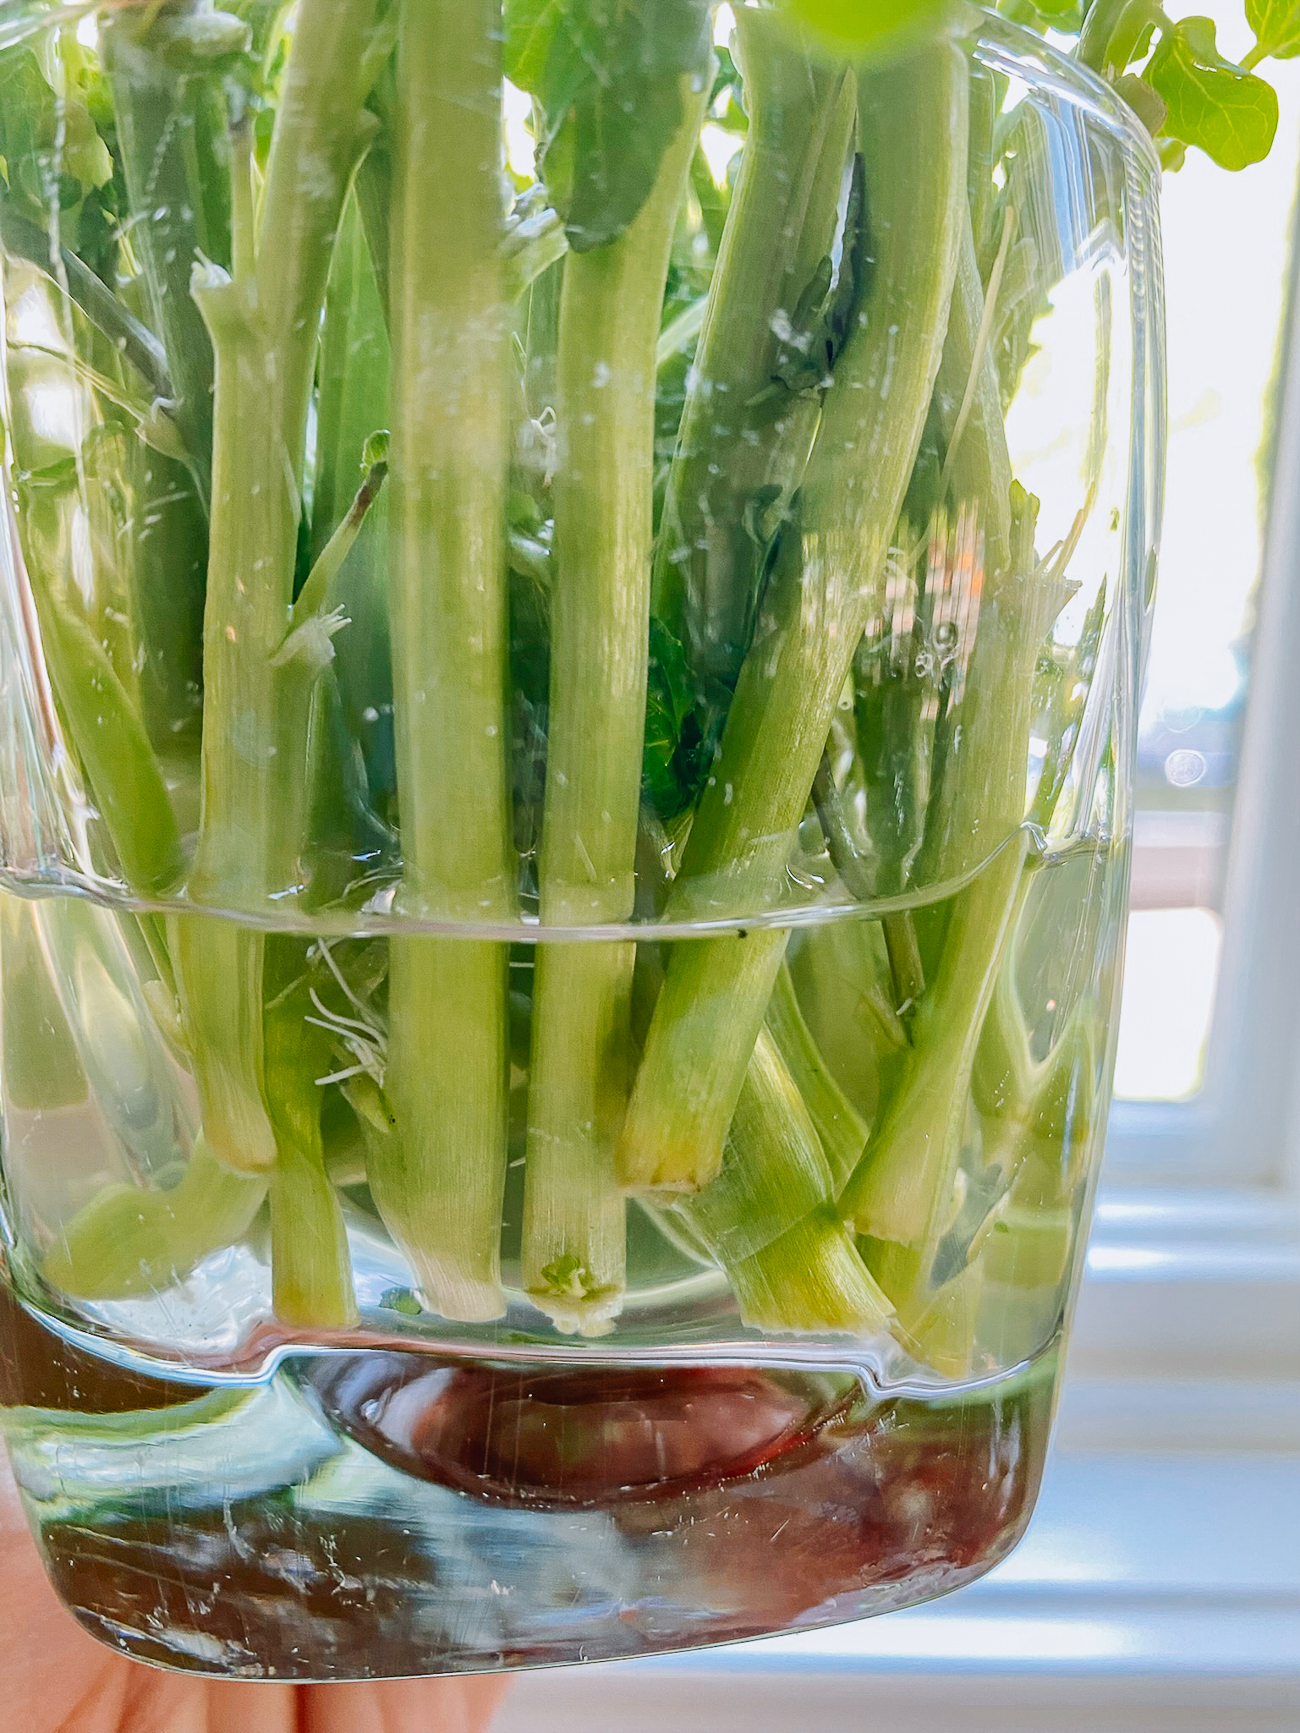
[177,0,374,1170]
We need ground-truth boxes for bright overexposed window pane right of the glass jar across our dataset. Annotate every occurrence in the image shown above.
[1116,40,1300,1129]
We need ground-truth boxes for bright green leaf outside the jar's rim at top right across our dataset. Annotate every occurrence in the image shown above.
[1146,17,1277,168]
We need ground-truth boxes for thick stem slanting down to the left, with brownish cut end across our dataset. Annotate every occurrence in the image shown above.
[619,43,967,1191]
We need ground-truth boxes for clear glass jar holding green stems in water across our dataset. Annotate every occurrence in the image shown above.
[0,0,1163,1679]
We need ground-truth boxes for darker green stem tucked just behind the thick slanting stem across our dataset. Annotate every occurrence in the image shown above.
[655,9,856,702]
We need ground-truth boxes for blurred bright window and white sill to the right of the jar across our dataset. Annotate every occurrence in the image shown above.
[497,0,1300,1733]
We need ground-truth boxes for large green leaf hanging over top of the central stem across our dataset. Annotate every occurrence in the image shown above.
[506,0,711,253]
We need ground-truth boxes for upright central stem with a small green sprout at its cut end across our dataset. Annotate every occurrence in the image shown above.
[522,90,704,1334]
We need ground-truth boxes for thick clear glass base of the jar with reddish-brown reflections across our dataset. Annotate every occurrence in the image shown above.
[5,1319,1056,1681]
